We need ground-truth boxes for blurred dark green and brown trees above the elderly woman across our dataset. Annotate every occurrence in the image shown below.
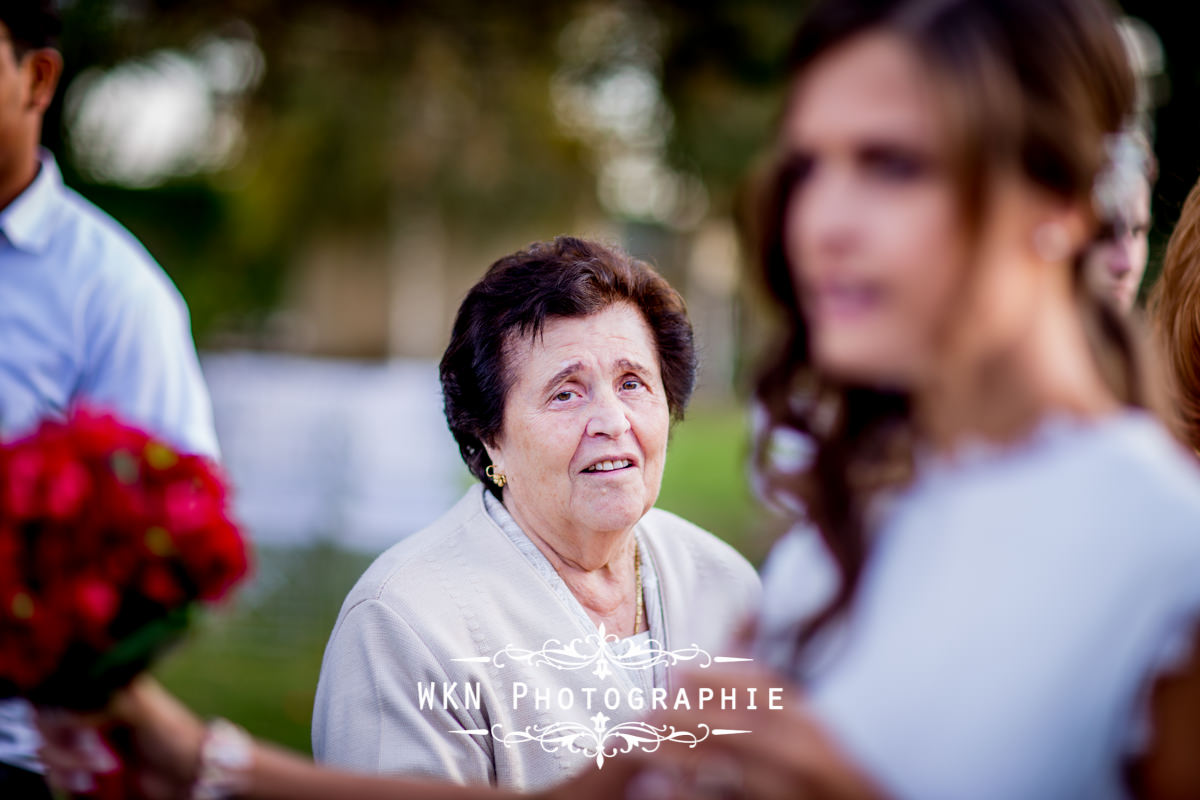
[39,0,816,350]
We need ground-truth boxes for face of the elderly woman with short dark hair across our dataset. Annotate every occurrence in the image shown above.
[488,303,670,535]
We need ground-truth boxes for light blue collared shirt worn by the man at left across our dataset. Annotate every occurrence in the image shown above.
[0,150,218,770]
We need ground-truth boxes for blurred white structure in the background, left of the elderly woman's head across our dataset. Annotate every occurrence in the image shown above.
[200,353,468,552]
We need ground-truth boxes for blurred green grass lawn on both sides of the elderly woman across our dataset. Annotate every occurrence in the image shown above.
[156,408,768,753]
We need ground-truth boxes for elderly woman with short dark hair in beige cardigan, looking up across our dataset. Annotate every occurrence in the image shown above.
[313,237,758,789]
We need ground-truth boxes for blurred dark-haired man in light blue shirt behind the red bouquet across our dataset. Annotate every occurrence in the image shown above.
[0,0,218,798]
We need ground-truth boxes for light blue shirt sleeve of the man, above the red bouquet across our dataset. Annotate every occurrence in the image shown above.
[73,264,220,458]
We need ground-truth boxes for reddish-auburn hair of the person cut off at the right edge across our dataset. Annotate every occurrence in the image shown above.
[1150,184,1200,452]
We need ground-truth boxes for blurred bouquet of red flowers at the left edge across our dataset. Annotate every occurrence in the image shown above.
[0,410,247,709]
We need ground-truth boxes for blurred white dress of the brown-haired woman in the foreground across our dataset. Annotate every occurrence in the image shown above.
[760,413,1200,800]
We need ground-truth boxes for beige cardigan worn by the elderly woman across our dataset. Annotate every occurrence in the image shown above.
[313,485,760,789]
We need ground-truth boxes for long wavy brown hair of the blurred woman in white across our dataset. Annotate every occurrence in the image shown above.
[756,0,1144,654]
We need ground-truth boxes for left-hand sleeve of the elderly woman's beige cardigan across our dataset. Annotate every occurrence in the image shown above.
[312,600,496,784]
